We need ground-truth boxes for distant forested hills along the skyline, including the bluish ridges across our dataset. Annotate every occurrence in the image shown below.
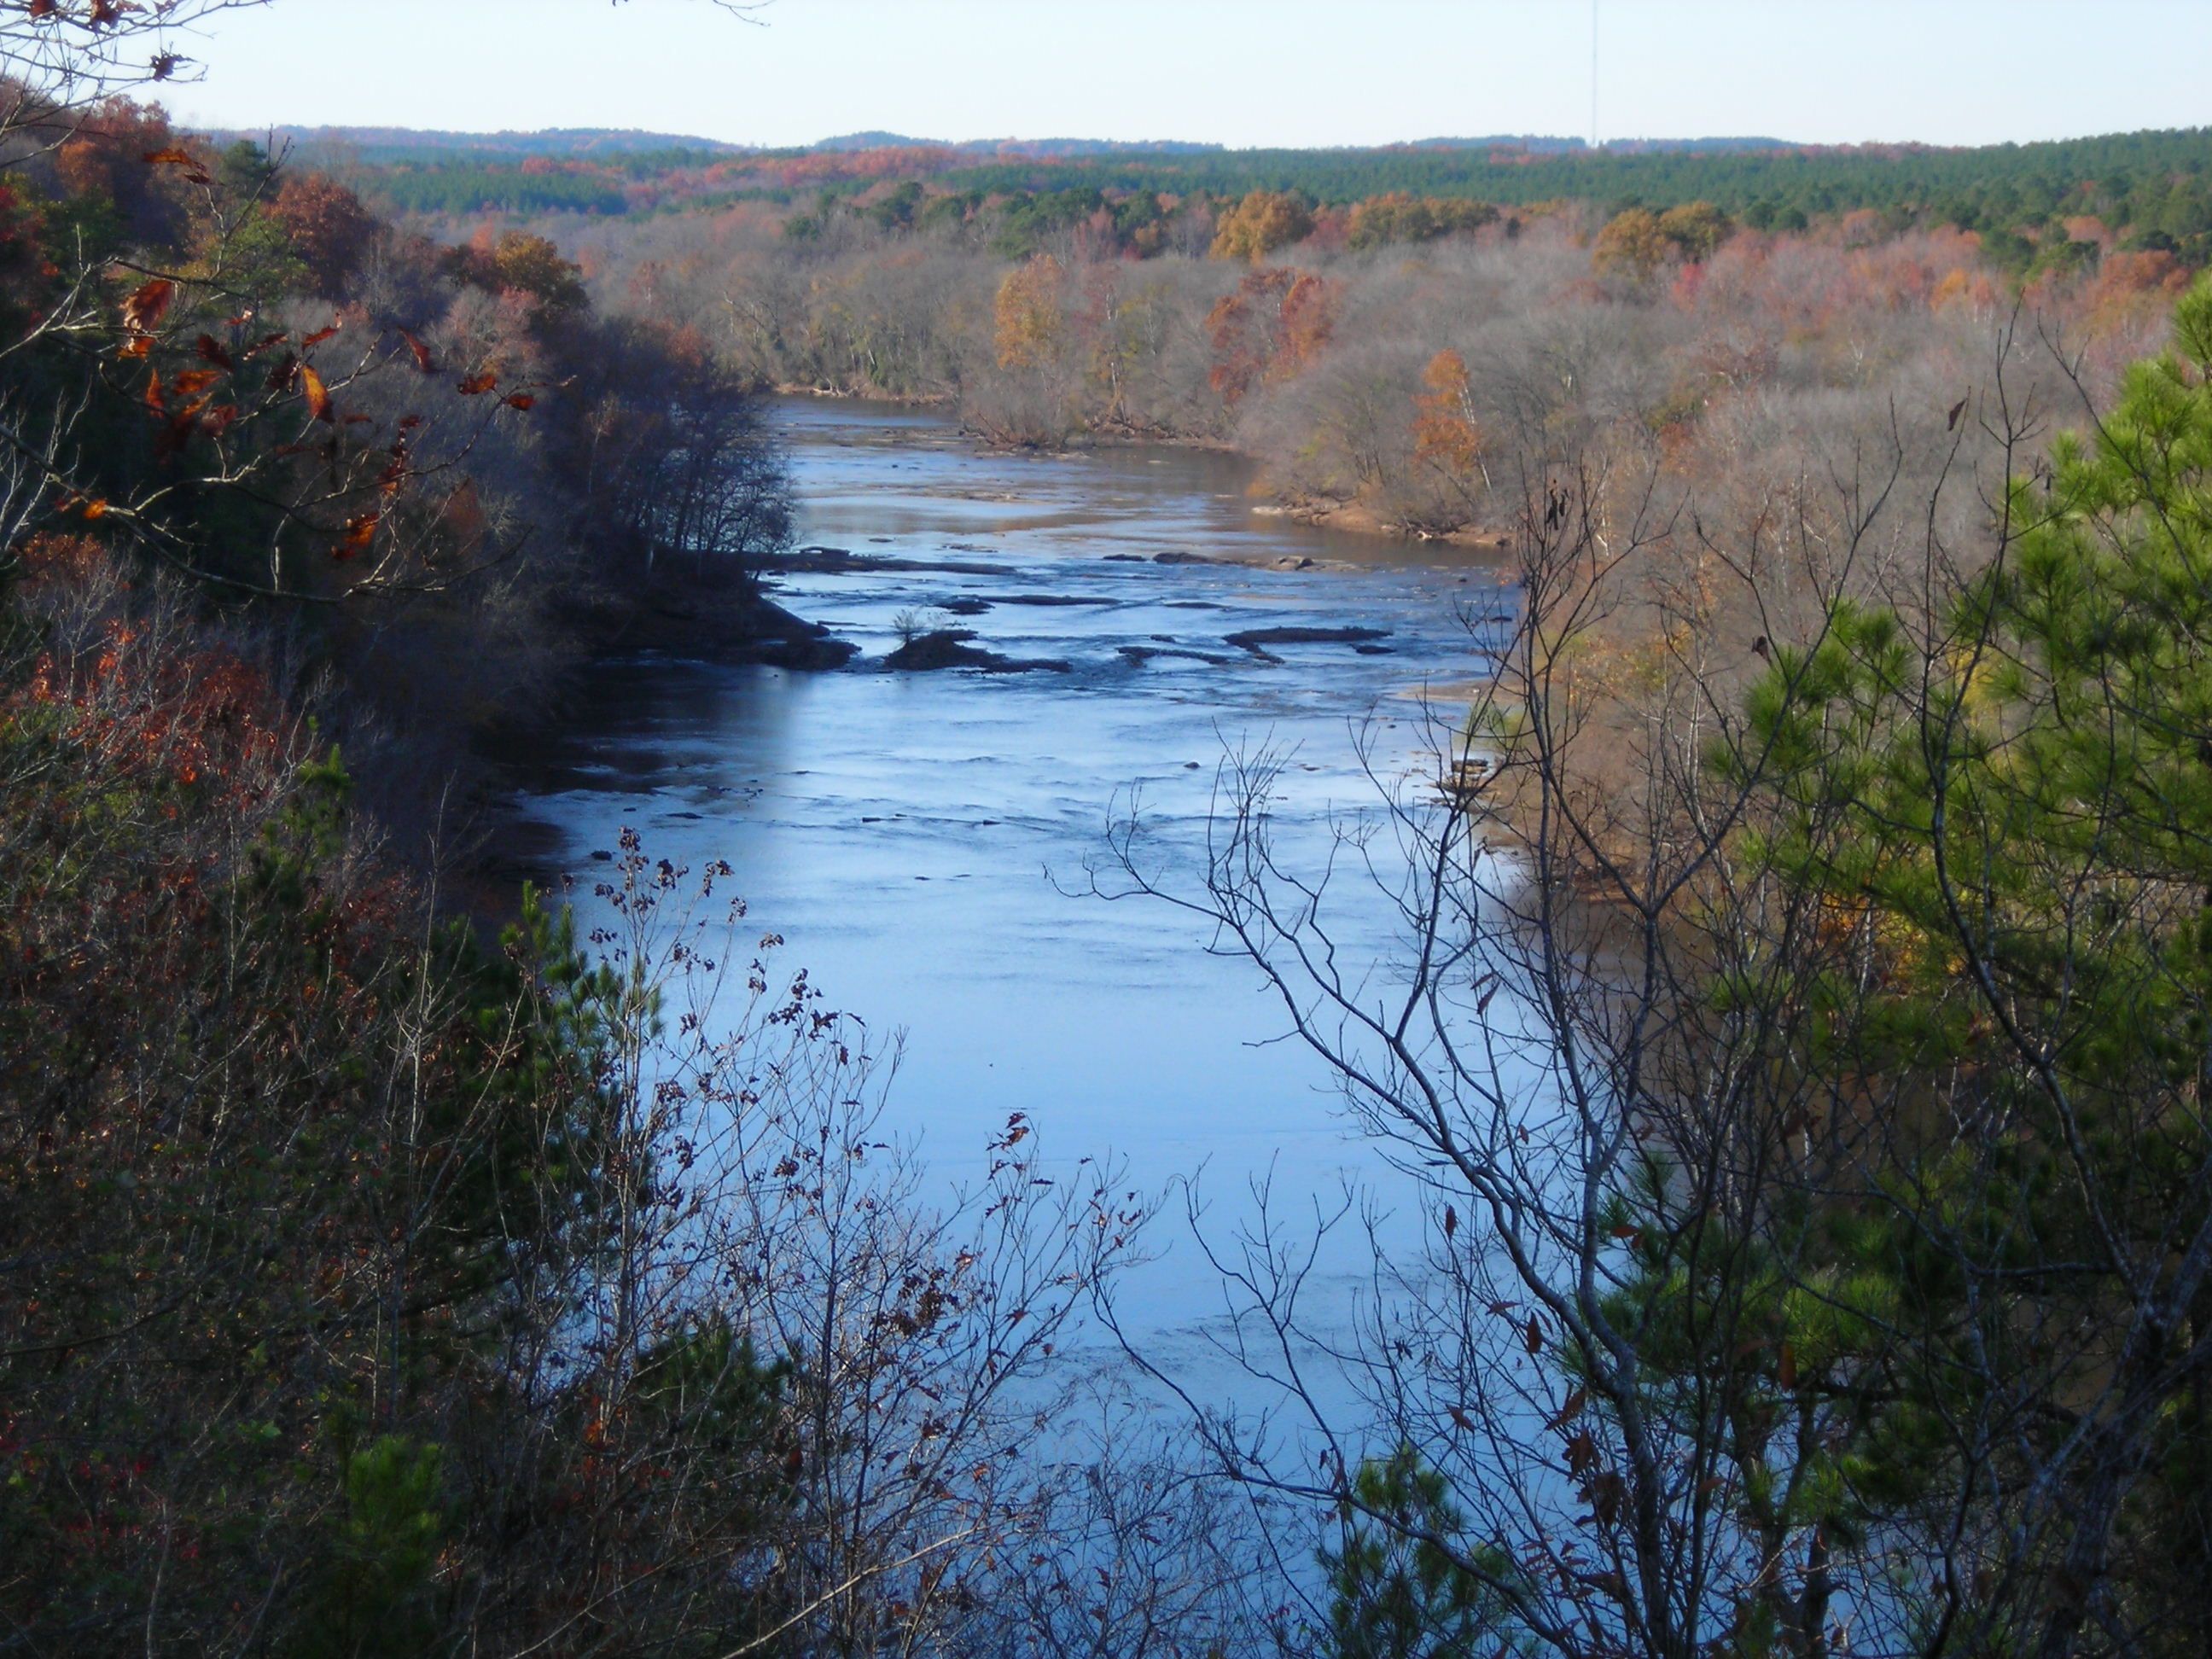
[279,126,2212,260]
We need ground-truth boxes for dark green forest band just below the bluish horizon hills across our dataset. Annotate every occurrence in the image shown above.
[335,128,2212,263]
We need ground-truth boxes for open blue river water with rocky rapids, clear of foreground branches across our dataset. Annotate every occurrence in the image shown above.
[520,400,1502,1371]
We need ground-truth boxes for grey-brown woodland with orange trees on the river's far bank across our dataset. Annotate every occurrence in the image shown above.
[513,151,2192,553]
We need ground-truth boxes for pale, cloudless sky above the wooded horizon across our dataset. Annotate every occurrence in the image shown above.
[171,0,2212,146]
